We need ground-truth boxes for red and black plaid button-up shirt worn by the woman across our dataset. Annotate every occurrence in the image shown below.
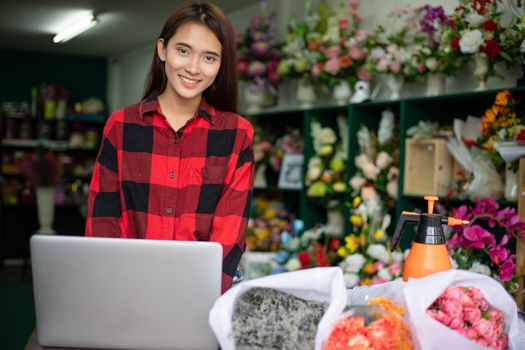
[86,95,254,292]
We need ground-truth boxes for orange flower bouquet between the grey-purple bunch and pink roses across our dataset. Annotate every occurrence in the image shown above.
[323,298,414,350]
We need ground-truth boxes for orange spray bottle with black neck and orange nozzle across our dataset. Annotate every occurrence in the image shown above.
[390,196,469,282]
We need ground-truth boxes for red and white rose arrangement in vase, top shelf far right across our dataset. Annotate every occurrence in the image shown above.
[446,0,519,90]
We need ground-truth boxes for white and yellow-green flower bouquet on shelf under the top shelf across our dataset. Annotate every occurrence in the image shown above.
[305,116,348,210]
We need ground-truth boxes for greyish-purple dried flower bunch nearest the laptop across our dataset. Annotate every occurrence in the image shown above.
[232,288,328,350]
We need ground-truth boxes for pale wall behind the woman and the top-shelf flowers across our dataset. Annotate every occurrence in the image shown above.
[108,0,520,111]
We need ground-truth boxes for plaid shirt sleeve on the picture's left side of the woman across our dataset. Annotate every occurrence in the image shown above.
[86,117,123,237]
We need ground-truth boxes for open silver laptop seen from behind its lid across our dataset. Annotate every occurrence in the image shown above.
[30,235,222,350]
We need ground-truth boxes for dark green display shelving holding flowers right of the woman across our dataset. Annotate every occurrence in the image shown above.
[250,87,525,248]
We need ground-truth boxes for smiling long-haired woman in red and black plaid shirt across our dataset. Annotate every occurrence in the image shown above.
[86,2,254,292]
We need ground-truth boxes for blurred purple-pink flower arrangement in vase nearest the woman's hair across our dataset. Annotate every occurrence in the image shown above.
[237,0,281,113]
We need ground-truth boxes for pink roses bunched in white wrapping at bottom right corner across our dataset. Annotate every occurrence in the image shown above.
[427,285,509,349]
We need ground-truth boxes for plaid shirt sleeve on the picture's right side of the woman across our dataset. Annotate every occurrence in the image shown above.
[210,124,255,293]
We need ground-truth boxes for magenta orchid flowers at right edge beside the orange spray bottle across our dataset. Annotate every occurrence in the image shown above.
[447,198,525,293]
